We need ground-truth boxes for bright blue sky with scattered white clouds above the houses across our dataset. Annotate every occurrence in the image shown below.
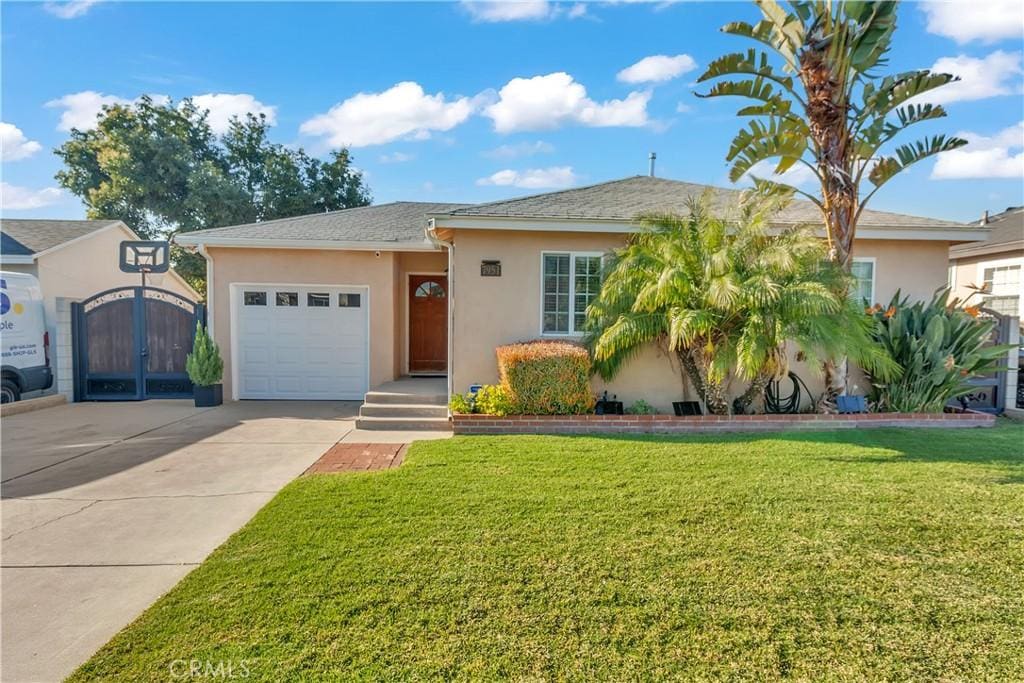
[0,0,1024,220]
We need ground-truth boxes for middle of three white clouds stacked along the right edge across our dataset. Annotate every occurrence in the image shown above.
[912,50,1024,104]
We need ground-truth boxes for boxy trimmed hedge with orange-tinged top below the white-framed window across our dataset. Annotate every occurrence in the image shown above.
[497,341,594,415]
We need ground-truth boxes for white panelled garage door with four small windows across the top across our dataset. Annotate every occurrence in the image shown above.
[231,285,370,400]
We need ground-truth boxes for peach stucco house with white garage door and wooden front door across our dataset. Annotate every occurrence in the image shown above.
[176,176,987,412]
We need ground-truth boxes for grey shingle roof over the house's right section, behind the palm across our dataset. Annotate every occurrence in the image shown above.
[442,175,968,228]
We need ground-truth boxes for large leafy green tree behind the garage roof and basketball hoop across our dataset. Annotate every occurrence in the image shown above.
[56,97,370,288]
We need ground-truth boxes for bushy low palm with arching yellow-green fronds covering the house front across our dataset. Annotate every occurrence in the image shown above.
[587,191,891,415]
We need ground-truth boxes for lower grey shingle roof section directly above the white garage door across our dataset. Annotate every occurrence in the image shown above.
[178,202,467,243]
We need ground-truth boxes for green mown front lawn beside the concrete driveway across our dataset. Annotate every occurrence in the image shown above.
[73,425,1024,681]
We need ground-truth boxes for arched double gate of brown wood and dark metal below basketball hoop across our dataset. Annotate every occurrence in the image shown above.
[72,287,206,400]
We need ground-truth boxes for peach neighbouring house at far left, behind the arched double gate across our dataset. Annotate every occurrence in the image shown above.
[0,218,201,396]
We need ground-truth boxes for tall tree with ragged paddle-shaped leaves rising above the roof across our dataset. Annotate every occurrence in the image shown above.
[697,0,967,269]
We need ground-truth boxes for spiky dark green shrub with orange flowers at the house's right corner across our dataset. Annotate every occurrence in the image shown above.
[866,289,1011,413]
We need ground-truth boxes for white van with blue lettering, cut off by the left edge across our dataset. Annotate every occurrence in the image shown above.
[0,270,53,403]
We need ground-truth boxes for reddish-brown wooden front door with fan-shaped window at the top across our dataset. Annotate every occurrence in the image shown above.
[409,275,447,373]
